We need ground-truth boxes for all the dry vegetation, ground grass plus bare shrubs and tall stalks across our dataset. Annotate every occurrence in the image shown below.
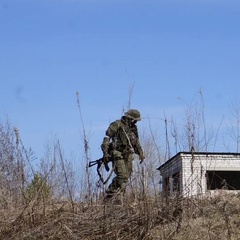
[0,93,240,240]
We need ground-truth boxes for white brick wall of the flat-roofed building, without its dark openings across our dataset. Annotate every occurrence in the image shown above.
[159,152,240,197]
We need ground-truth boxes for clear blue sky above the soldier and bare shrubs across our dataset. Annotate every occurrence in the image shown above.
[0,0,240,162]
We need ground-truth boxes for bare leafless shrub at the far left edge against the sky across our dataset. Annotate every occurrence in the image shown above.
[0,121,34,208]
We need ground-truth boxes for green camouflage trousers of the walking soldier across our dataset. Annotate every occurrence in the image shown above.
[106,151,133,194]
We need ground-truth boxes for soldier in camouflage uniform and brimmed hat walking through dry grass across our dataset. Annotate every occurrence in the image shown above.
[101,109,145,197]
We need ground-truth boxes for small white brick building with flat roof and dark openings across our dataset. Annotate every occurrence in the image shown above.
[158,152,240,197]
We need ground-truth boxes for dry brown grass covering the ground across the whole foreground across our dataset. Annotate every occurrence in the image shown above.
[0,192,240,240]
